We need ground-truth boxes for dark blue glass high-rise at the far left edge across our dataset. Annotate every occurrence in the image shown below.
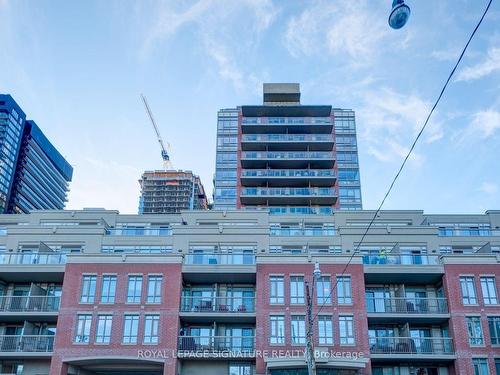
[0,95,73,213]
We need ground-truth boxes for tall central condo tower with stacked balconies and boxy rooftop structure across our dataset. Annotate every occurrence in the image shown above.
[214,83,362,214]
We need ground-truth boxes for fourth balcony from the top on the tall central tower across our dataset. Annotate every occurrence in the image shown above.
[240,169,337,187]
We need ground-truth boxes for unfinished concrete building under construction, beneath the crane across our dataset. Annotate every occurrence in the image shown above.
[139,170,208,214]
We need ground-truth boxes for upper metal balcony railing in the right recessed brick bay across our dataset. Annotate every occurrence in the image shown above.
[366,297,448,314]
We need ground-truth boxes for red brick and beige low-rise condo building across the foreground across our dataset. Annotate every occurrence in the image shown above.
[0,210,500,375]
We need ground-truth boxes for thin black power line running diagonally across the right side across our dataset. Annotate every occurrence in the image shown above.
[312,0,493,322]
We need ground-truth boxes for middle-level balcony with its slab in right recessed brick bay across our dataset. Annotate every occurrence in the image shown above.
[366,297,449,323]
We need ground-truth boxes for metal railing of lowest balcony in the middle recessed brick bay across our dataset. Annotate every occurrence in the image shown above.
[178,336,255,353]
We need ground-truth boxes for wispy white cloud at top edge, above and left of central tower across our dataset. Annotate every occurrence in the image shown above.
[142,0,279,91]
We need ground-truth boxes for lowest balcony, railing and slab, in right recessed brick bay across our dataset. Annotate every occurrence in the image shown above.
[369,337,455,360]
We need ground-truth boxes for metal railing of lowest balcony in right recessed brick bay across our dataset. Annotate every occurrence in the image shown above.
[369,337,454,356]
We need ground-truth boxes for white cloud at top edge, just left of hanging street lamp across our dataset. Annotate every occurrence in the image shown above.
[285,0,390,65]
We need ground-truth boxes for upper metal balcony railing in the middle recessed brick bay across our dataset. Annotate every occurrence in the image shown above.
[181,296,255,313]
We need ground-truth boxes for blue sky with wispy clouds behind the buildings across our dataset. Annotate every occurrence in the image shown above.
[0,0,500,213]
